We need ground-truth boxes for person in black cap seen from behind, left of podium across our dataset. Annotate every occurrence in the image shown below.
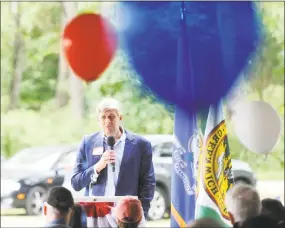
[43,187,81,228]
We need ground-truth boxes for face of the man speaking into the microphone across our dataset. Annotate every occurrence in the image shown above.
[99,109,122,137]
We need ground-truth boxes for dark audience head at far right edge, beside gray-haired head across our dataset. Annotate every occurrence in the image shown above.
[261,198,285,222]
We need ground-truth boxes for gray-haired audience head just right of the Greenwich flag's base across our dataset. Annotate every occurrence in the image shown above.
[225,184,261,222]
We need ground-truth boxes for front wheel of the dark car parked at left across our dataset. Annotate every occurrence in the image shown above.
[26,186,47,215]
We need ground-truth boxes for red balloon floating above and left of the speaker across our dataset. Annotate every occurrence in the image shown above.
[62,13,117,82]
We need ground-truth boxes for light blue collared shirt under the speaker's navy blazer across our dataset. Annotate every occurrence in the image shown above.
[93,129,126,196]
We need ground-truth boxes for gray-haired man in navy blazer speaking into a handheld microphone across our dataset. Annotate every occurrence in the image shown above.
[71,98,155,217]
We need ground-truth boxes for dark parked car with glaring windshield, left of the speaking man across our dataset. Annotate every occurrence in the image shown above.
[1,146,76,215]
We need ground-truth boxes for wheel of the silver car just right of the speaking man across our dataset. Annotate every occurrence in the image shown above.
[148,187,166,220]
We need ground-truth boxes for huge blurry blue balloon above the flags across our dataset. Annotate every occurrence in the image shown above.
[118,2,261,112]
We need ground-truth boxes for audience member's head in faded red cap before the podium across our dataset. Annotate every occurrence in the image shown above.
[115,196,143,228]
